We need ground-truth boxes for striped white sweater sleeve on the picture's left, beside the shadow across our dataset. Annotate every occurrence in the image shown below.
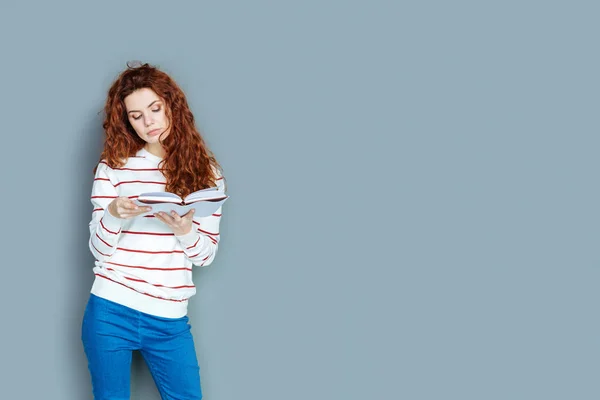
[89,163,124,261]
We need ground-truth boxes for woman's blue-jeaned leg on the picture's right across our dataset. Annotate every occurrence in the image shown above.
[140,313,202,400]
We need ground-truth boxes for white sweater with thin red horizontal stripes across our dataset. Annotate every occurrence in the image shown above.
[89,149,224,318]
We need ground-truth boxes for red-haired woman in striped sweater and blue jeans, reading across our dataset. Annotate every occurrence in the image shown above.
[82,64,225,400]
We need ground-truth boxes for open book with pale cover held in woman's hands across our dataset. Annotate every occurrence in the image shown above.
[134,187,229,217]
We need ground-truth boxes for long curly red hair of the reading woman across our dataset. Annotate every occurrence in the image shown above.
[94,63,222,197]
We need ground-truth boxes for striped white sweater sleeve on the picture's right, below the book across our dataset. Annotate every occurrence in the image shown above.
[175,173,225,267]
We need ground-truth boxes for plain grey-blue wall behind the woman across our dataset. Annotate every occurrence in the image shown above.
[0,0,600,400]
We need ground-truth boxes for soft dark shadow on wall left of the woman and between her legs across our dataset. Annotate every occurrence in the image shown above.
[66,105,160,400]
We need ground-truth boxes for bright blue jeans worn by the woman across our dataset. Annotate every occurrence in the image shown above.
[81,294,202,400]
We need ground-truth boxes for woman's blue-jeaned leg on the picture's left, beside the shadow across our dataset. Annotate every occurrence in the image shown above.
[81,294,139,400]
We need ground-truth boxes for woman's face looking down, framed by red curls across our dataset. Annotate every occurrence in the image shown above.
[124,88,170,146]
